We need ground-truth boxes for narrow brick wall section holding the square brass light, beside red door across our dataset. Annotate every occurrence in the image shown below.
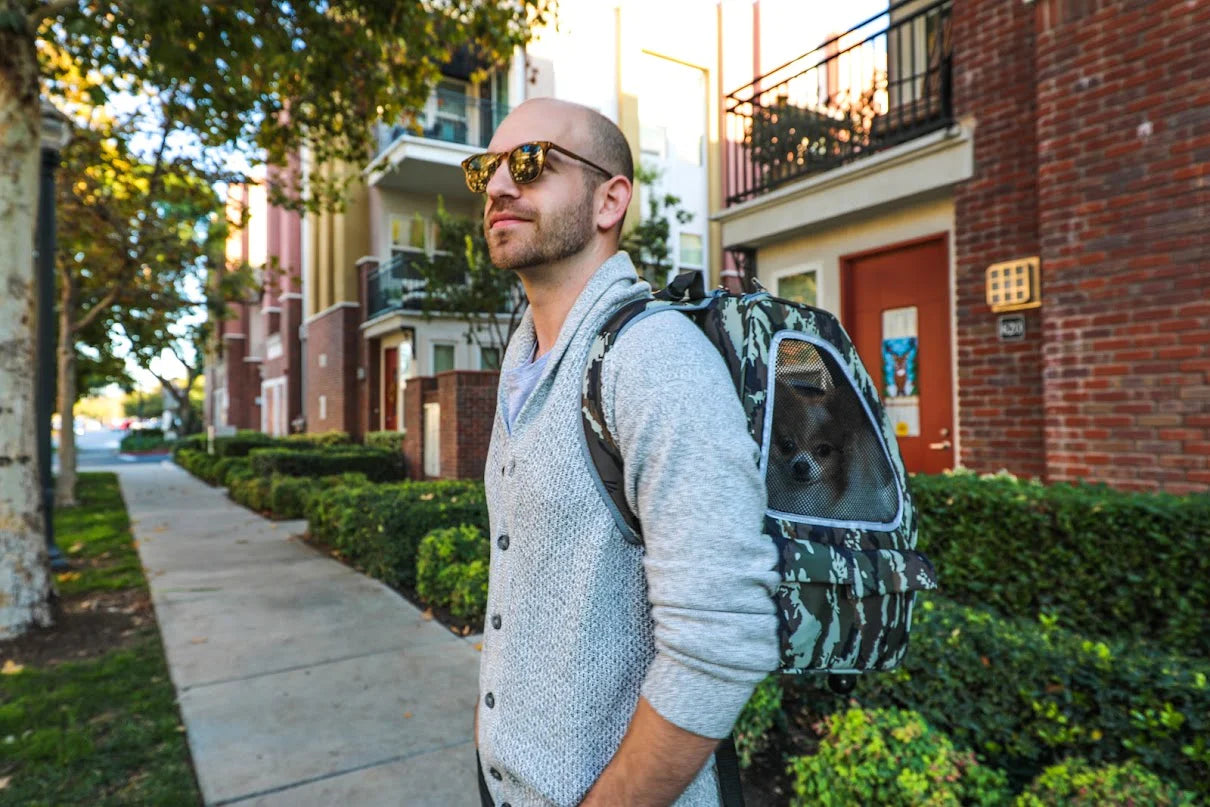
[952,0,1045,477]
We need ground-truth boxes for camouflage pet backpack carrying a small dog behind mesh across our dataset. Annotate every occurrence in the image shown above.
[581,272,937,692]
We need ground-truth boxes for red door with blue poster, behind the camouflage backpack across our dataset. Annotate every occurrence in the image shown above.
[841,235,955,473]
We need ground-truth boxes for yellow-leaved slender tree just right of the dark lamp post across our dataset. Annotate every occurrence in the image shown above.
[56,116,224,507]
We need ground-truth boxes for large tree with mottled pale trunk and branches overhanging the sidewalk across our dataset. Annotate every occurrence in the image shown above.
[0,0,552,635]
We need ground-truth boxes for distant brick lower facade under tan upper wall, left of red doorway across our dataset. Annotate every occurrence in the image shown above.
[303,305,361,438]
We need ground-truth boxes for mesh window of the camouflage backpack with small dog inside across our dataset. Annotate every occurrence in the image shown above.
[765,336,899,524]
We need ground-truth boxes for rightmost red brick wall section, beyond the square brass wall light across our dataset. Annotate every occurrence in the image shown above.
[1030,0,1210,492]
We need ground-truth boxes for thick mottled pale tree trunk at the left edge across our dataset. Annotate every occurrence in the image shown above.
[0,6,51,639]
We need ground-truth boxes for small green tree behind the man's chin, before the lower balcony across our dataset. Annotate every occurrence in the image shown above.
[411,197,528,353]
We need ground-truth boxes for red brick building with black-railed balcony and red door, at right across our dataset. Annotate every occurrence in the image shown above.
[714,0,1210,492]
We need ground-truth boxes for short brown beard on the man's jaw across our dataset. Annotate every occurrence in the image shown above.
[484,183,595,271]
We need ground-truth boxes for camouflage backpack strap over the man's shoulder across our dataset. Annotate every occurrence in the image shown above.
[580,272,709,546]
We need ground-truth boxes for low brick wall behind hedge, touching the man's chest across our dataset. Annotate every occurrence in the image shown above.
[403,370,500,479]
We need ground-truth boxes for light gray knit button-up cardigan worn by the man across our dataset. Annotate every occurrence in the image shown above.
[477,253,778,807]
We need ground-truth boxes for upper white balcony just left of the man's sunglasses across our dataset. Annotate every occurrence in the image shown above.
[365,81,511,197]
